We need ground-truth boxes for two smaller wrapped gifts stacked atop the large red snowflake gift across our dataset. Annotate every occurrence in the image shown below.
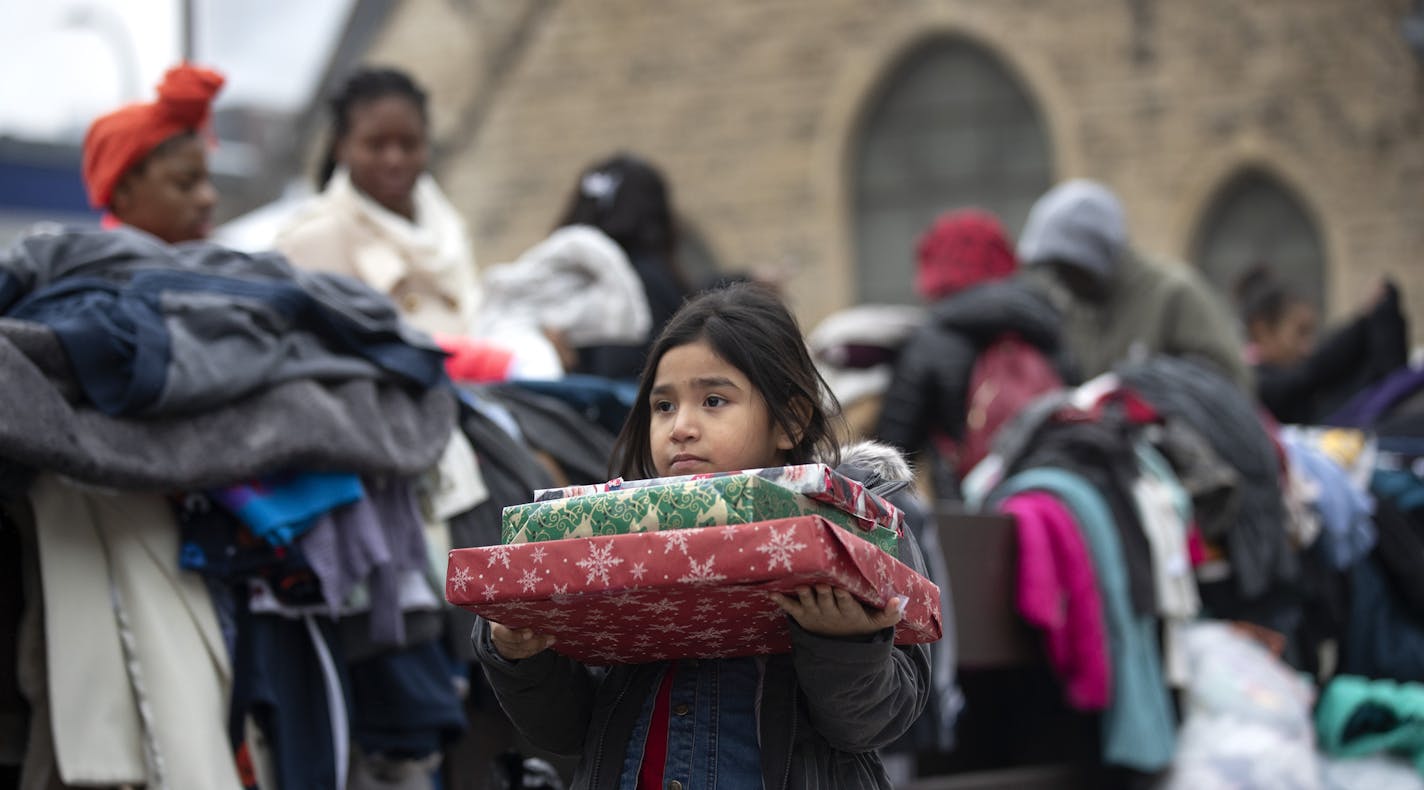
[503,464,904,554]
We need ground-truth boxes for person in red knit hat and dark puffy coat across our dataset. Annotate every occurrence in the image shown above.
[874,209,1068,497]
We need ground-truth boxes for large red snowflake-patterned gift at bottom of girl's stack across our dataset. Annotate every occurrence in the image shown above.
[446,515,941,665]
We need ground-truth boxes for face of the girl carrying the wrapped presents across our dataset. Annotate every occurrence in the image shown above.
[648,340,795,477]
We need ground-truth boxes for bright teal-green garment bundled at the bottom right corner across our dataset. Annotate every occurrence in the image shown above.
[1316,675,1424,774]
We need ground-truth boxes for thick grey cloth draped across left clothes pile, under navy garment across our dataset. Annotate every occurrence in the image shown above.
[0,319,456,491]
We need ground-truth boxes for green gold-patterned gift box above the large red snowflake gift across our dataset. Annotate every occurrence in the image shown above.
[503,474,899,557]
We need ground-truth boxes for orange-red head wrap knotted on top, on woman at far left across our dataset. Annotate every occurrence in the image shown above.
[84,64,224,208]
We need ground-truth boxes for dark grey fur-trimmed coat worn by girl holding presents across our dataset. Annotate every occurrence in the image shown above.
[473,447,930,790]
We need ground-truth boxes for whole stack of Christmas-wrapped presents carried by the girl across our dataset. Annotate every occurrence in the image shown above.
[446,464,941,665]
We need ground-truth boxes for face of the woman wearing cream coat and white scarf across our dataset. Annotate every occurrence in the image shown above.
[336,95,430,216]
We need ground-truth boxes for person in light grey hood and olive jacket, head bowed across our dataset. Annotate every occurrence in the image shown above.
[1018,179,1250,389]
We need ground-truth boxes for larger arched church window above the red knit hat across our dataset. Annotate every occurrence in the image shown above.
[854,38,1052,302]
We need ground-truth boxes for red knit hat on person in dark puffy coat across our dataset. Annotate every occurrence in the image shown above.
[914,209,1018,302]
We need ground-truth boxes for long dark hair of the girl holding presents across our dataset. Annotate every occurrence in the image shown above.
[611,283,840,478]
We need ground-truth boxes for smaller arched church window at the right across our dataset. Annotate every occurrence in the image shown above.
[1192,169,1326,315]
